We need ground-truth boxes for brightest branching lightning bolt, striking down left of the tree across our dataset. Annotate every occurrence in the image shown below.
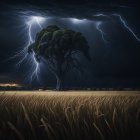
[14,16,46,82]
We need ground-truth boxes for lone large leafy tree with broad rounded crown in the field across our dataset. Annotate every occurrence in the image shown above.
[28,25,90,90]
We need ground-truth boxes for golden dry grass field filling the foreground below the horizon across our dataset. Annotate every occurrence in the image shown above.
[0,91,140,140]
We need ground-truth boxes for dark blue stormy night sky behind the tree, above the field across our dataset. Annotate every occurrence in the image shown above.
[0,0,140,88]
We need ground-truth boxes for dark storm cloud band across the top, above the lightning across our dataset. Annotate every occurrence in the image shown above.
[0,0,139,21]
